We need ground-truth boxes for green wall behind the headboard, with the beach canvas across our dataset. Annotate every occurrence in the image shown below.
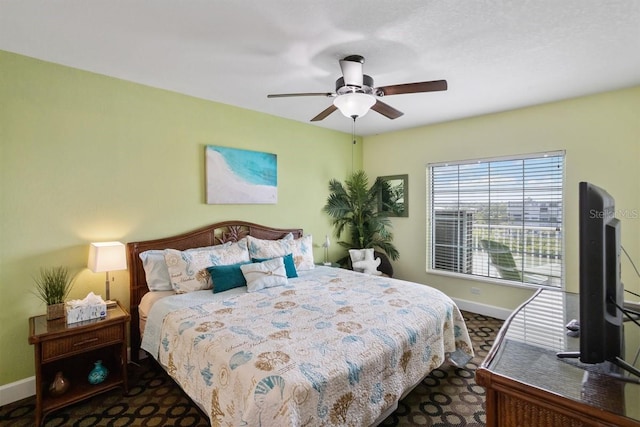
[0,51,362,385]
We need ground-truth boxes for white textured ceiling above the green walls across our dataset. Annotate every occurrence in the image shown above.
[0,0,640,135]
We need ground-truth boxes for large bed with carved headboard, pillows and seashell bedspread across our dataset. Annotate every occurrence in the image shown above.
[127,221,473,426]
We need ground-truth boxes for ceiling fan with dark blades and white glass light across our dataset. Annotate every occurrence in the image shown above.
[267,55,447,122]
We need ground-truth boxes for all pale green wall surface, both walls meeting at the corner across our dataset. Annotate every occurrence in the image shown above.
[0,47,640,392]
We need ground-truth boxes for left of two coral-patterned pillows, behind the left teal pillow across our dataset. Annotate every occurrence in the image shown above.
[164,239,251,294]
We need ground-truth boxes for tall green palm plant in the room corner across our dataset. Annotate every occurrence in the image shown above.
[323,171,400,260]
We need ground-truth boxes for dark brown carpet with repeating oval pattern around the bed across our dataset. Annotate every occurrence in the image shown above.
[0,312,502,427]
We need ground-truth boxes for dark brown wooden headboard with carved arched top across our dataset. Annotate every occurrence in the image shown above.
[127,221,302,361]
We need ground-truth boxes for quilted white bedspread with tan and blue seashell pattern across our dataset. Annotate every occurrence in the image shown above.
[152,267,473,427]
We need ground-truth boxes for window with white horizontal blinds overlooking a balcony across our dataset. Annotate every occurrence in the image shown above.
[427,152,564,287]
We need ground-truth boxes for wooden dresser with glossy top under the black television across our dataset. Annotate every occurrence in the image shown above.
[476,290,640,427]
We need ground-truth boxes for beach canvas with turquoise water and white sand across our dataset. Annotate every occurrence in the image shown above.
[205,145,278,204]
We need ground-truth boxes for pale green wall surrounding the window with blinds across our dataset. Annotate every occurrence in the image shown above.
[363,87,640,308]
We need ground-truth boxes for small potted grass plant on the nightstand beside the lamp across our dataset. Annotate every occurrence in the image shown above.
[33,267,74,320]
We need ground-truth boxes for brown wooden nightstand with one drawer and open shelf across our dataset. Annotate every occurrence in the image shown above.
[29,304,130,426]
